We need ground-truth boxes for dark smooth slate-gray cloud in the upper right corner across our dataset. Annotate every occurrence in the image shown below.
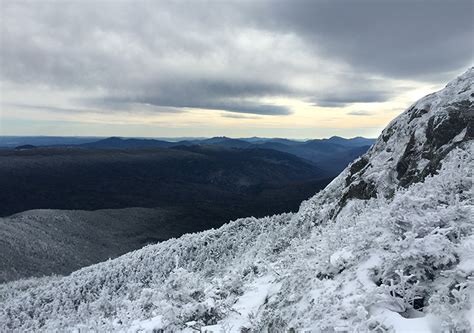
[264,0,474,80]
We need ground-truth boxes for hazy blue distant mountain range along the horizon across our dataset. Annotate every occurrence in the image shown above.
[0,136,375,176]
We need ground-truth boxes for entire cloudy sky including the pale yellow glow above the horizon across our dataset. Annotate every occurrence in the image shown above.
[0,0,474,139]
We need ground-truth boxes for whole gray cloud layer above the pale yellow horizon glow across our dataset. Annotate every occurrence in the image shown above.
[0,0,474,115]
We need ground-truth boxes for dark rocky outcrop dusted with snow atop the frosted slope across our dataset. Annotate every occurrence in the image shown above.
[298,67,474,217]
